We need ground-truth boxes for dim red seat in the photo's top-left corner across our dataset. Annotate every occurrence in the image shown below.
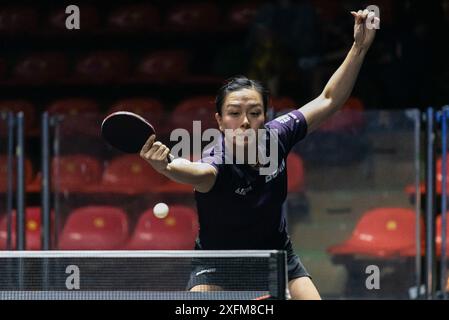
[0,6,38,34]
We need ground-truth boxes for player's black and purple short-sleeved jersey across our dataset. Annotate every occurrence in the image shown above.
[195,110,307,250]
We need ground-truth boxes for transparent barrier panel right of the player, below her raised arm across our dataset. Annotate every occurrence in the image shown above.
[287,110,419,299]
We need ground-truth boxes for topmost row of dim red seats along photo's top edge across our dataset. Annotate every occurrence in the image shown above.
[0,1,259,33]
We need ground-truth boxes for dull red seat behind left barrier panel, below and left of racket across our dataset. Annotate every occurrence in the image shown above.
[52,154,103,192]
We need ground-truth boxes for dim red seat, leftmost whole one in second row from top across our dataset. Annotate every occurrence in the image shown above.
[13,53,67,83]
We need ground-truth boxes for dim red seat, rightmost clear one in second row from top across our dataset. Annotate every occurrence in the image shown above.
[137,50,188,82]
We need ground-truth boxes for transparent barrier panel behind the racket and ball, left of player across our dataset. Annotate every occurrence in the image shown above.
[51,114,198,250]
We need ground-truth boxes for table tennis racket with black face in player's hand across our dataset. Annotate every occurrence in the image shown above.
[101,111,173,162]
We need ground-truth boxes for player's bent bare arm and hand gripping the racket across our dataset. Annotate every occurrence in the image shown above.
[140,135,217,192]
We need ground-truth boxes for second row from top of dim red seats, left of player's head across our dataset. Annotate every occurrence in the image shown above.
[0,49,223,84]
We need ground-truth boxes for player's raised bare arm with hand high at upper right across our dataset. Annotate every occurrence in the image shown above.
[299,10,379,133]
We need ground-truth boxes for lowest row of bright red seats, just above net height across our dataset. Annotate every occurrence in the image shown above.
[0,205,449,258]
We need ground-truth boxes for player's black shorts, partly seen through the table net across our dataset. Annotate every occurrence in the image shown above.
[187,240,311,291]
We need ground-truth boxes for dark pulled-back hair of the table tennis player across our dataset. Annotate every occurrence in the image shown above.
[215,76,269,115]
